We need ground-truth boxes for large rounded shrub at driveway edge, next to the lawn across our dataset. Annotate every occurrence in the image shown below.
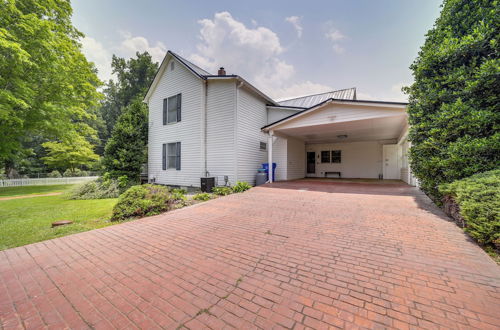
[111,184,179,221]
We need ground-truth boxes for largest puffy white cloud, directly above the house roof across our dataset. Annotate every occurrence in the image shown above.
[189,12,329,97]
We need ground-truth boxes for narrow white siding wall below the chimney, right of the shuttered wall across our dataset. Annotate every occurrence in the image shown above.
[207,80,236,185]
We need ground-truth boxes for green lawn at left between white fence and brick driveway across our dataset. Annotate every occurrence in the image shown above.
[0,185,117,250]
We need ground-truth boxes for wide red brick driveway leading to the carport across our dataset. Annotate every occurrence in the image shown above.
[0,181,500,329]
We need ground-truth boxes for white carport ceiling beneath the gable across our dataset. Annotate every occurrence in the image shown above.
[276,115,406,143]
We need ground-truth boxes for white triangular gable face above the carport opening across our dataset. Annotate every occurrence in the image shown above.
[280,104,405,129]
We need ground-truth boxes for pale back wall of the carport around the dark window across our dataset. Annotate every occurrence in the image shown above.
[306,141,382,179]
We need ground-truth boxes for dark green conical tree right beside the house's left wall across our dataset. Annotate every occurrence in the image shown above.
[103,98,148,181]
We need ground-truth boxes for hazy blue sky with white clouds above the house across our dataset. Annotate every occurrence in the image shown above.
[73,0,440,100]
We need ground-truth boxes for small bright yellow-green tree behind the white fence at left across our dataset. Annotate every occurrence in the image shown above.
[42,134,99,177]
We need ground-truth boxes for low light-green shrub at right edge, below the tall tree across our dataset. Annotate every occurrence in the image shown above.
[439,169,500,246]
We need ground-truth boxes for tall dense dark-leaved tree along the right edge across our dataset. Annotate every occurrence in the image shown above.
[406,0,500,199]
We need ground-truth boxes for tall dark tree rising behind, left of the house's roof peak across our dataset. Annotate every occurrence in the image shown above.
[101,52,158,143]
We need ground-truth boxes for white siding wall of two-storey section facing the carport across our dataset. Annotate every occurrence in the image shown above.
[236,88,267,185]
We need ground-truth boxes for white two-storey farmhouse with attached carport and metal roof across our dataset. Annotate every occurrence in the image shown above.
[144,51,415,187]
